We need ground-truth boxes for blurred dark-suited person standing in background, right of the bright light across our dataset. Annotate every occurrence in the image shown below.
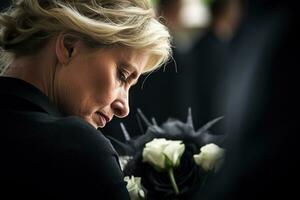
[182,0,244,131]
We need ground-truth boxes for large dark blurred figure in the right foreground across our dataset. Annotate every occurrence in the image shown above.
[194,0,300,200]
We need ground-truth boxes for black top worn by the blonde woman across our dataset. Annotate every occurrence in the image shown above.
[0,77,129,200]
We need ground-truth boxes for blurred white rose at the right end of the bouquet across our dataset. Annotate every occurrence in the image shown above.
[194,144,225,171]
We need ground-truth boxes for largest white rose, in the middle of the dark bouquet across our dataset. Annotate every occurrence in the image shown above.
[143,138,185,170]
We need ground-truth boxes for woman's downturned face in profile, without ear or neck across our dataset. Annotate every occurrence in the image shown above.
[54,44,149,128]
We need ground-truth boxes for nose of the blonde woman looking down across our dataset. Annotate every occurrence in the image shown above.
[111,90,129,118]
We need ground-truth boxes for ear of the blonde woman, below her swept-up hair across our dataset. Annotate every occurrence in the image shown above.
[55,33,77,64]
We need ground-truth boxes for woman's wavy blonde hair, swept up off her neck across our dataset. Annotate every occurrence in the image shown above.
[0,0,171,72]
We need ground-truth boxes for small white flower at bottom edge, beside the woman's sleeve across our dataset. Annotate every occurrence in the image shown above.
[124,176,145,200]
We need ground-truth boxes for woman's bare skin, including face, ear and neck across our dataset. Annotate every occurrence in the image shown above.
[4,34,149,128]
